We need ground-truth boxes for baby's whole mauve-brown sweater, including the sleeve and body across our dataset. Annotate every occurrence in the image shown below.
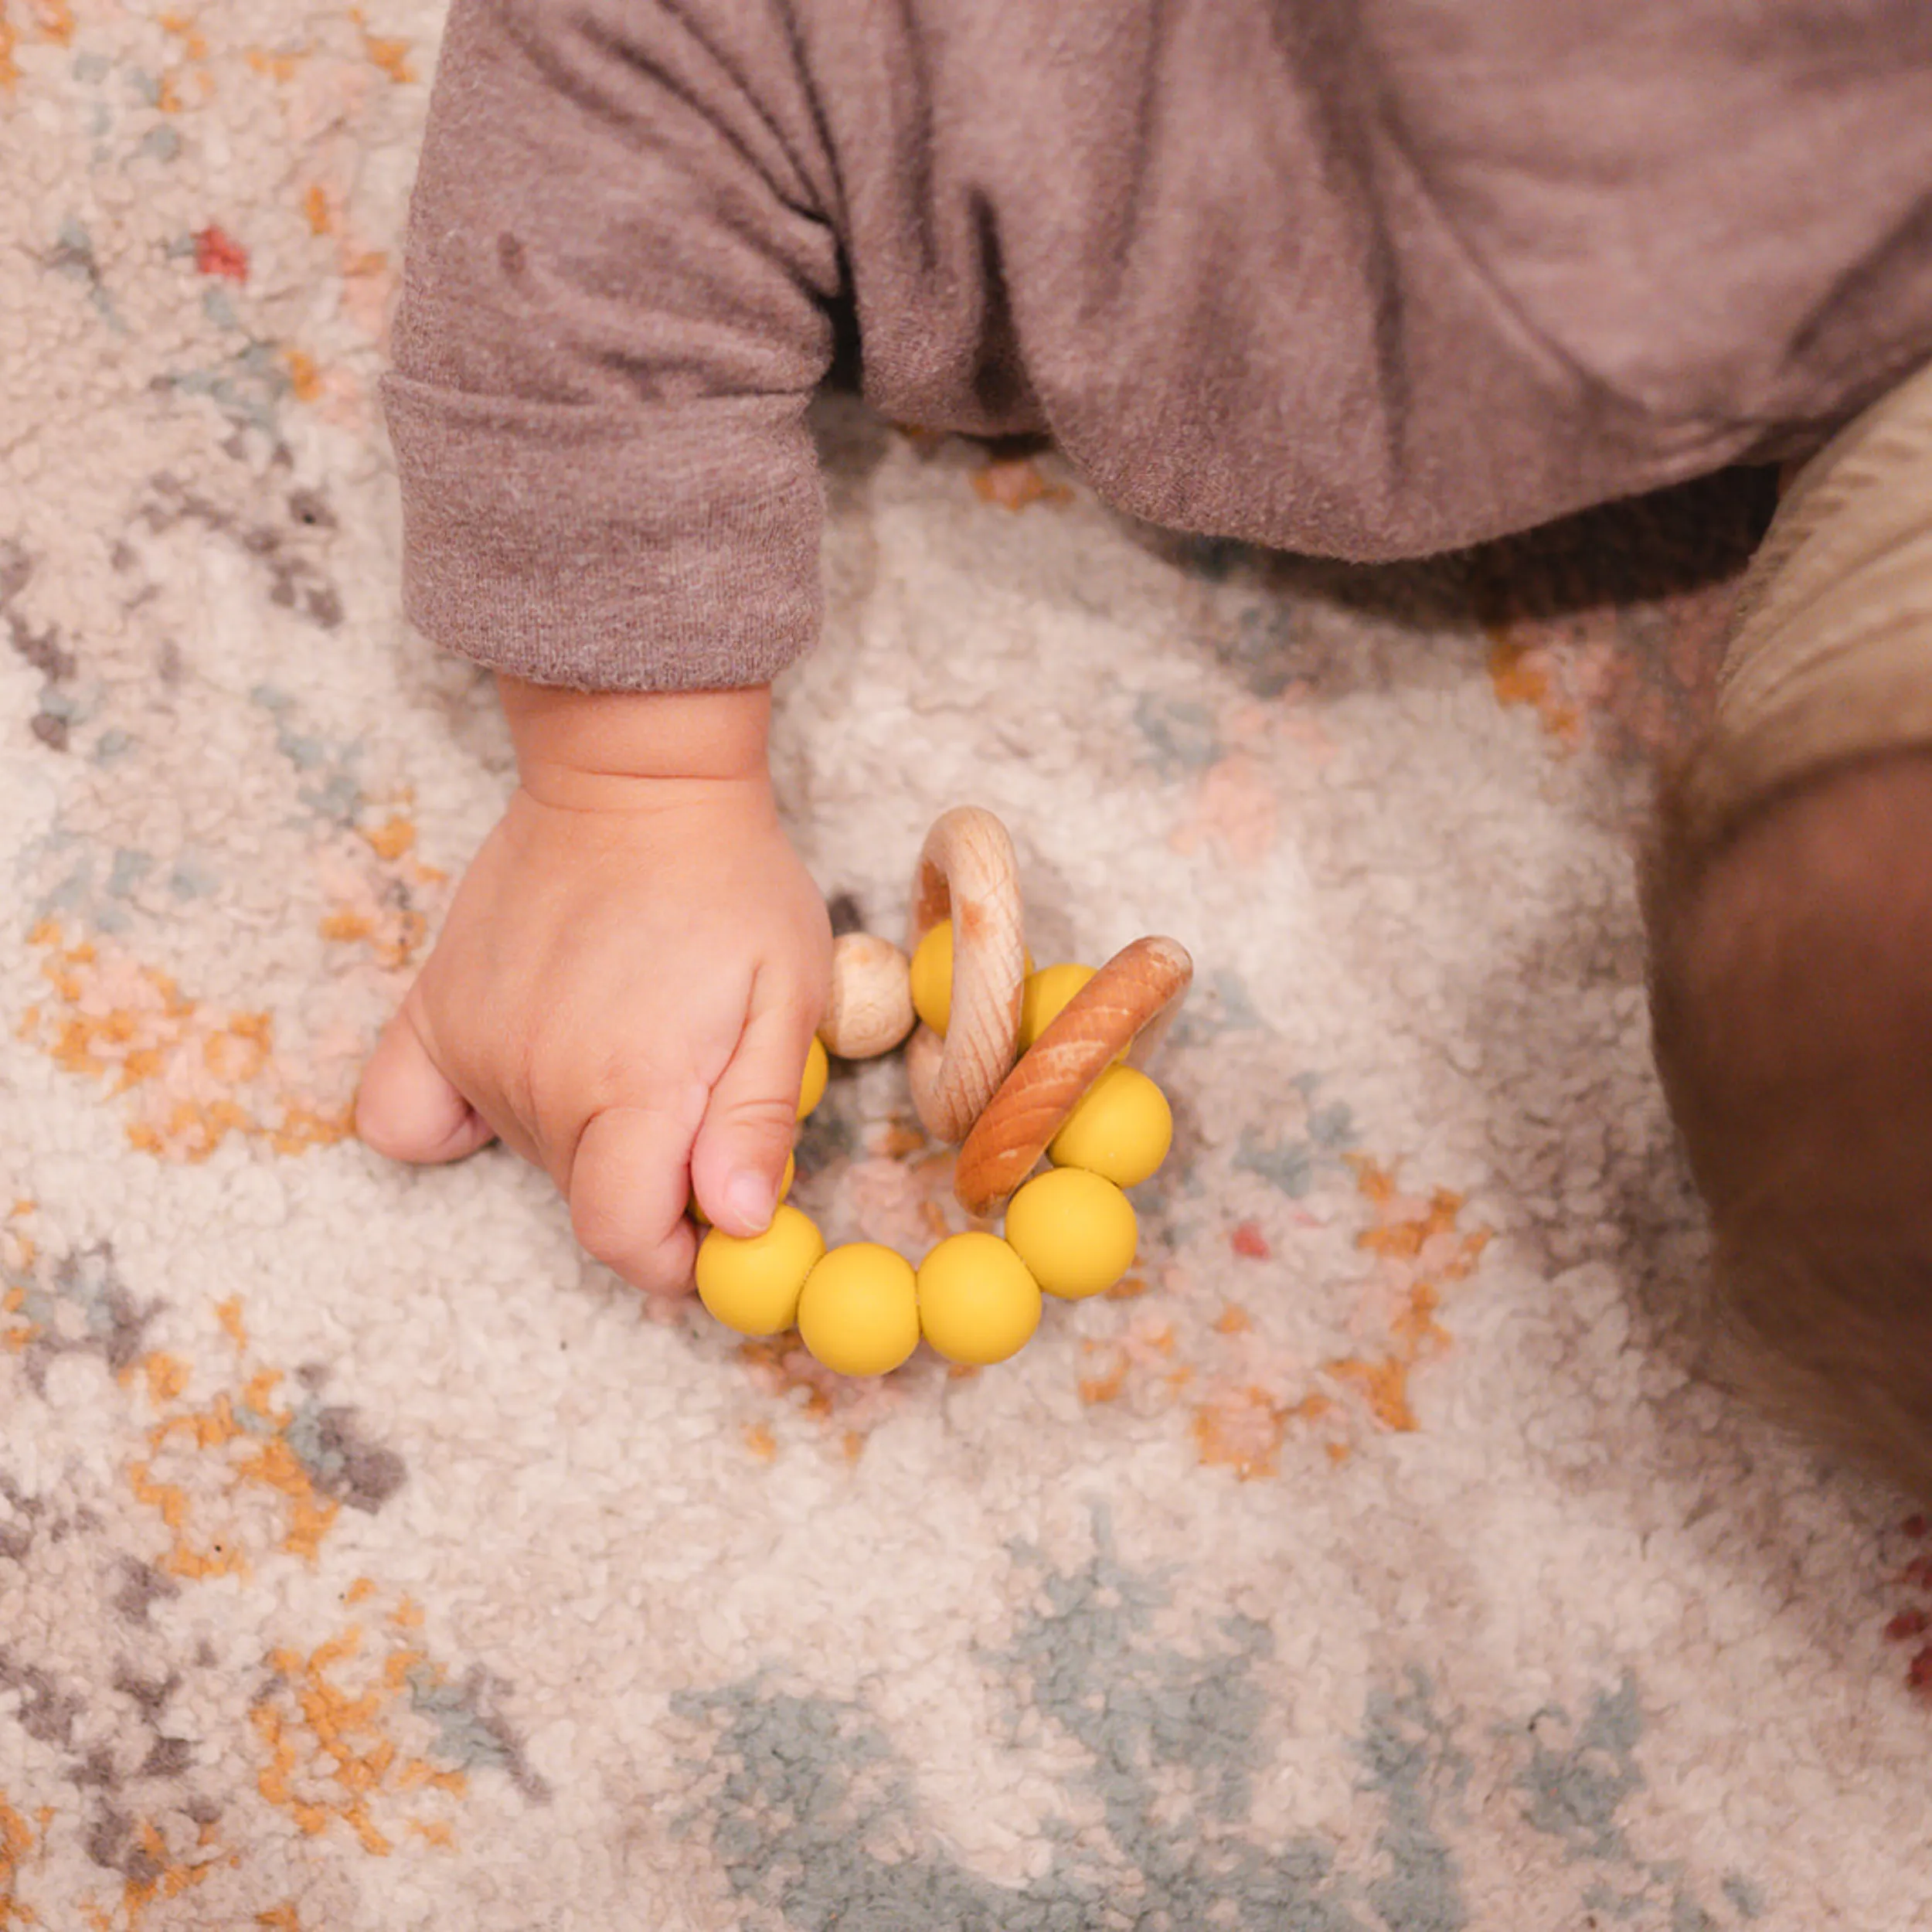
[385,0,1932,690]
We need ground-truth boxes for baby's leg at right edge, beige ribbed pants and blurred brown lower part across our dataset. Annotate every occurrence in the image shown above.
[1646,359,1932,1499]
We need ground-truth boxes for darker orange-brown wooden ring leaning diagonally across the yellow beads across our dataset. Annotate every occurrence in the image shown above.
[953,939,1194,1216]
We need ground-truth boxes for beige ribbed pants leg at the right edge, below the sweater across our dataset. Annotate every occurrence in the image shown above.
[1679,367,1932,846]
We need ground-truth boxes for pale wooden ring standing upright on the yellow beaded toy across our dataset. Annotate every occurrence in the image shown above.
[906,806,1026,1142]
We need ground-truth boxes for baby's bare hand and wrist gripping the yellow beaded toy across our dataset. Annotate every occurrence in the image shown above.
[355,680,831,1293]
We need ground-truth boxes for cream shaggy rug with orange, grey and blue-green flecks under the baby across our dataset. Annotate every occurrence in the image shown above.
[0,0,1932,1932]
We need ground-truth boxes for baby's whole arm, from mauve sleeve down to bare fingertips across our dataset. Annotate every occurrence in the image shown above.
[358,0,838,1291]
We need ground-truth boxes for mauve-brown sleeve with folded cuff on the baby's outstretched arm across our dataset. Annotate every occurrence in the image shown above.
[383,0,838,690]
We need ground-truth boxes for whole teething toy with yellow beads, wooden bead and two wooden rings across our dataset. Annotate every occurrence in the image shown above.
[694,808,1194,1376]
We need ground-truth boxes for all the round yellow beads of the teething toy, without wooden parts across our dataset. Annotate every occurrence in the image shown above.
[698,922,1173,1376]
